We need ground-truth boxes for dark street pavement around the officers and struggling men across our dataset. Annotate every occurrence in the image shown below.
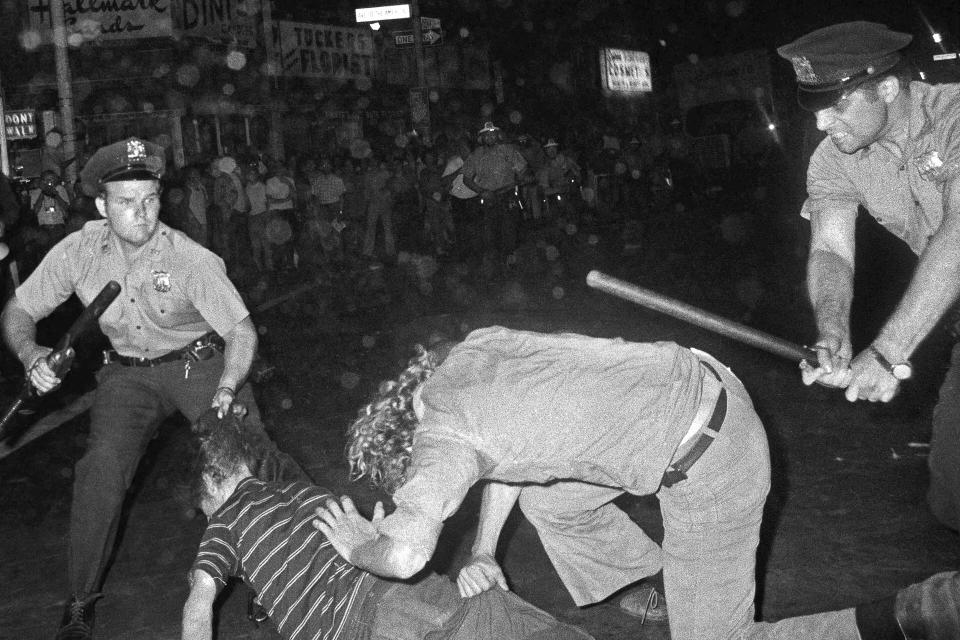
[0,218,960,640]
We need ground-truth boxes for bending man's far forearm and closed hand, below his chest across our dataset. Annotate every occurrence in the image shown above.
[457,482,521,598]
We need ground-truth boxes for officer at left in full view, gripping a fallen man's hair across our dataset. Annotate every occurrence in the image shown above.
[2,138,305,638]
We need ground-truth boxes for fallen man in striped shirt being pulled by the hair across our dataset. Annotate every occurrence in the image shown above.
[176,412,591,640]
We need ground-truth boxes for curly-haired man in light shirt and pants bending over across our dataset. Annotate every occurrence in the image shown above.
[314,327,960,640]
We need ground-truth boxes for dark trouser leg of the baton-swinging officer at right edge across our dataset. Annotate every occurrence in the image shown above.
[927,342,960,530]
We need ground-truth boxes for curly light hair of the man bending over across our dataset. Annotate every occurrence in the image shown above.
[347,345,449,494]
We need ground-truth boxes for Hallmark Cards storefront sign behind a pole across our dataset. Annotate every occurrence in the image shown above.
[27,0,173,43]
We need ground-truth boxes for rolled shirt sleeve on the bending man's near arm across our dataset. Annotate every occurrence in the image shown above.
[379,433,480,557]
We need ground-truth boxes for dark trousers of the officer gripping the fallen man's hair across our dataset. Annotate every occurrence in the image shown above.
[70,354,309,596]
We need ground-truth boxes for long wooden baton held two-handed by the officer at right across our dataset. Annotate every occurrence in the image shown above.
[587,270,820,367]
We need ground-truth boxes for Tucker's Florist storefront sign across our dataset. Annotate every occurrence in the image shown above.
[271,20,374,80]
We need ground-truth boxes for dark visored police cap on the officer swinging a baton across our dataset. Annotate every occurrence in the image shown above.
[777,21,913,111]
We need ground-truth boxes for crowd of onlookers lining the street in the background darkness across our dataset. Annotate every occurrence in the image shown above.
[0,123,712,296]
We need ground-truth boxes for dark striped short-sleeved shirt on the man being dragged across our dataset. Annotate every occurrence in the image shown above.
[193,477,375,640]
